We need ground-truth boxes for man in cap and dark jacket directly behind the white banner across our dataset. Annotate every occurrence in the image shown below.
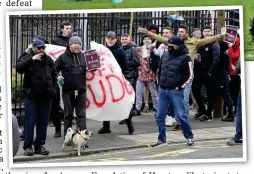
[98,31,134,134]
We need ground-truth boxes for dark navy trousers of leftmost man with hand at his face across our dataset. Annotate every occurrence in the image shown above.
[23,98,51,149]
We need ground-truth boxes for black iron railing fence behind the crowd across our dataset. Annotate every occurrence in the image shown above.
[8,9,239,115]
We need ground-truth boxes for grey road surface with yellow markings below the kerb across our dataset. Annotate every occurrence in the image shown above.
[24,140,243,163]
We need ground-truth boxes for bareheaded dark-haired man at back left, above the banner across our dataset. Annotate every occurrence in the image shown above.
[52,21,72,47]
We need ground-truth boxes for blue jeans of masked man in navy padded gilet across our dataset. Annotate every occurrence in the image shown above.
[156,88,193,143]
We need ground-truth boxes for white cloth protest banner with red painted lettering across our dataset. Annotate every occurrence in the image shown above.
[45,42,135,121]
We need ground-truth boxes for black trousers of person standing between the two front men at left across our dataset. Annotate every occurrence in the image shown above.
[50,87,62,132]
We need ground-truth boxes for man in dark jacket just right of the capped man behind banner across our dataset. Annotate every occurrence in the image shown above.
[119,34,140,124]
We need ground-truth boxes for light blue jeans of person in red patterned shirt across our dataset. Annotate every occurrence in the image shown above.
[136,79,158,110]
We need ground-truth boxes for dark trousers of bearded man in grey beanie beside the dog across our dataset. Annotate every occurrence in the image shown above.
[62,91,86,136]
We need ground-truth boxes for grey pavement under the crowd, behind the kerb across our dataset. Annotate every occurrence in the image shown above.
[14,110,235,163]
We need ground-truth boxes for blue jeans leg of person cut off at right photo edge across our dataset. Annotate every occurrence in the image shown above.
[234,90,243,141]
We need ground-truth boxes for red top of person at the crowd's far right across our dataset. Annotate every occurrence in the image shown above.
[228,37,240,75]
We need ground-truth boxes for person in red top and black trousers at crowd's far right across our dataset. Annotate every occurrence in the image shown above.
[228,37,240,116]
